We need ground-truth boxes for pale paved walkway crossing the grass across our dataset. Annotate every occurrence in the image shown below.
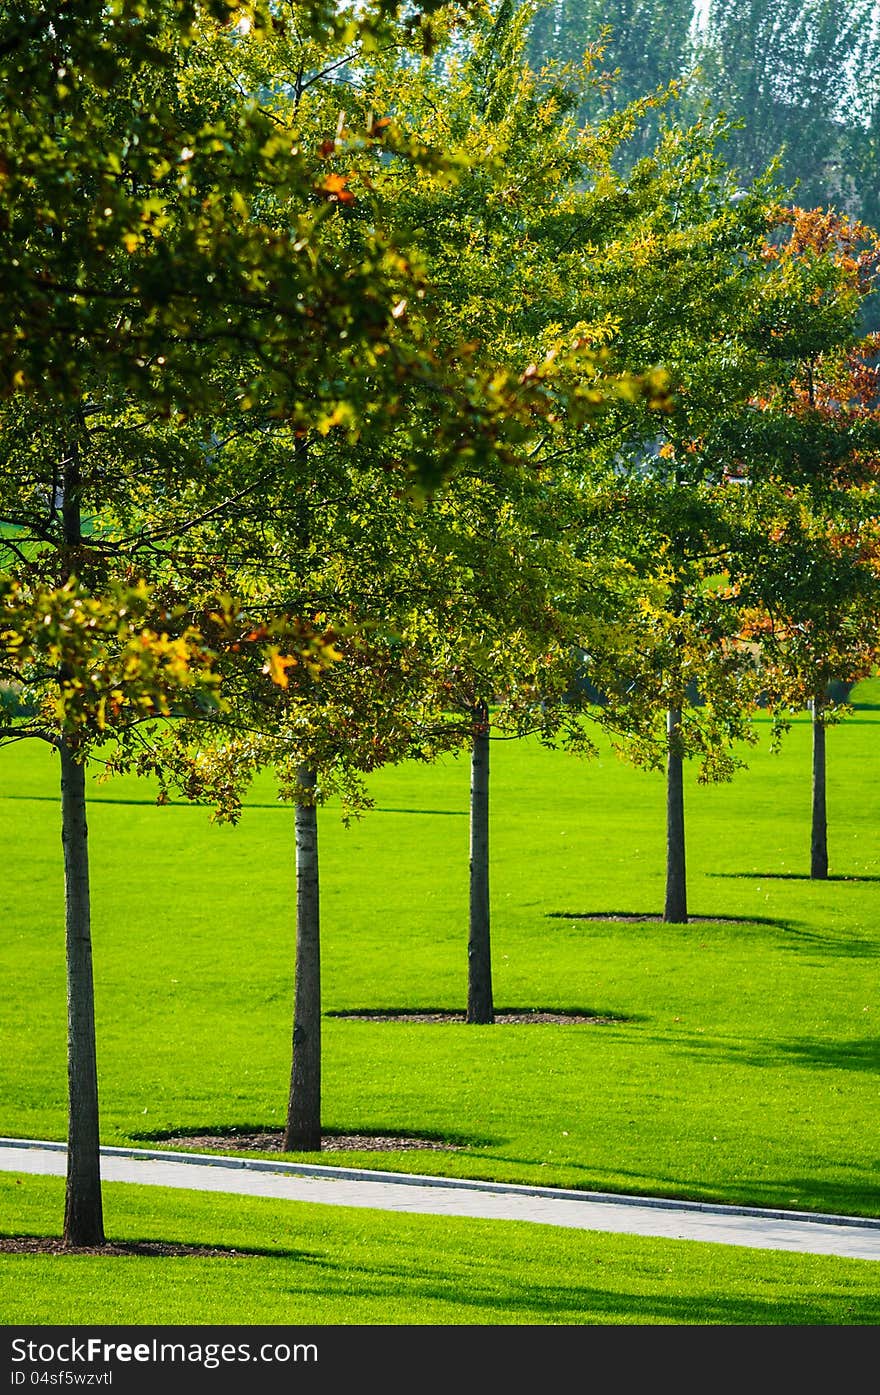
[0,1138,880,1260]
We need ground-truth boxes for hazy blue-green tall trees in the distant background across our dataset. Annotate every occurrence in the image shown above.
[529,0,880,245]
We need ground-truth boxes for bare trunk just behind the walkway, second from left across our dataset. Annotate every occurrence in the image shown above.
[285,766,321,1152]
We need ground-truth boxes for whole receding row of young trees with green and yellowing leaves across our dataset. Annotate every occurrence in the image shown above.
[0,0,880,1244]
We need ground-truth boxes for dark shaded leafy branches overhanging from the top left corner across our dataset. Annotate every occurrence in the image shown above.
[0,0,655,496]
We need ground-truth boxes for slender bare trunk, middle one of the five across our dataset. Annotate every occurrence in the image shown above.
[467,703,495,1025]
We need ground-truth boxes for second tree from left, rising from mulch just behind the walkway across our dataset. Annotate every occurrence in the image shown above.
[155,428,518,1151]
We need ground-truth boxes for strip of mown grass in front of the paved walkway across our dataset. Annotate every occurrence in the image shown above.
[0,1175,880,1325]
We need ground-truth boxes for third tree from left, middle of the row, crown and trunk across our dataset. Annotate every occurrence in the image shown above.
[354,3,677,993]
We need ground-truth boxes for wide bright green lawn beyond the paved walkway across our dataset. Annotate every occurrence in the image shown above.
[0,710,880,1321]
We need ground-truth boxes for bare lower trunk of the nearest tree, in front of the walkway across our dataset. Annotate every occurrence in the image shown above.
[59,738,105,1246]
